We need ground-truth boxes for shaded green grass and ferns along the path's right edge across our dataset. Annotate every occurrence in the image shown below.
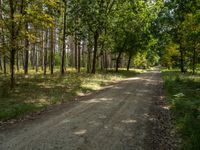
[162,70,200,150]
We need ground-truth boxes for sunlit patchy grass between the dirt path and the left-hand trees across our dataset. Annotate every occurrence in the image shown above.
[0,69,139,121]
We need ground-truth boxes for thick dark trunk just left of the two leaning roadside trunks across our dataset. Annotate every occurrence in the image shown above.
[92,31,99,74]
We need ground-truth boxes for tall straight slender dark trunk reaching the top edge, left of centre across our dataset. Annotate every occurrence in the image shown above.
[61,1,67,75]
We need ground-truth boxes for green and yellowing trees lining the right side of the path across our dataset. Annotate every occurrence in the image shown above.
[154,0,200,74]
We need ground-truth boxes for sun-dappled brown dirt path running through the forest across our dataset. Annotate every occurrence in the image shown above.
[0,70,165,150]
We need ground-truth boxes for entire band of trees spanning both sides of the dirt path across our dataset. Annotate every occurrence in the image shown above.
[0,0,200,88]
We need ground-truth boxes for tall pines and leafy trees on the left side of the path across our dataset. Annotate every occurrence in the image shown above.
[0,0,162,88]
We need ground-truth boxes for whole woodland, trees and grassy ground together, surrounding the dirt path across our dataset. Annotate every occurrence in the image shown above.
[0,0,200,150]
